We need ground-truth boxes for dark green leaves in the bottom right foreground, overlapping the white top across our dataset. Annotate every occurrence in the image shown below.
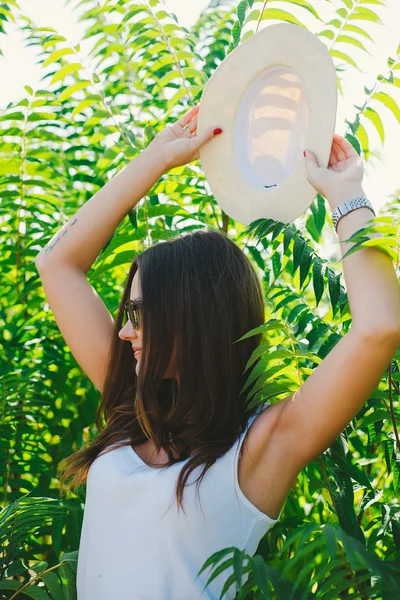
[202,524,398,600]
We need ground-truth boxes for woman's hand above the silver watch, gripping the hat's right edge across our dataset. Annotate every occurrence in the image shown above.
[305,133,364,205]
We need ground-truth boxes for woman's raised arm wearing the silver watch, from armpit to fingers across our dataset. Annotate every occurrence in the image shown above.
[244,134,400,518]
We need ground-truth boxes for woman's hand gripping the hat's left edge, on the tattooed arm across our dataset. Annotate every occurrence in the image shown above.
[148,104,222,171]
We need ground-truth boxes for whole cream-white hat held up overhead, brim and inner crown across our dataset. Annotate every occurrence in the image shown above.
[197,23,337,225]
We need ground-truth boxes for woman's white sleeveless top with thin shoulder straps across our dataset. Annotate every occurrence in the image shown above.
[77,402,282,600]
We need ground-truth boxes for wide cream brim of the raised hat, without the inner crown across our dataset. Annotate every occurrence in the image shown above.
[197,23,337,225]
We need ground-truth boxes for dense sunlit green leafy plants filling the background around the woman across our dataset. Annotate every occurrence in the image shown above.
[0,0,400,600]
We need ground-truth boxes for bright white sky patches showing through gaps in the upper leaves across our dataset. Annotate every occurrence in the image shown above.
[0,0,400,217]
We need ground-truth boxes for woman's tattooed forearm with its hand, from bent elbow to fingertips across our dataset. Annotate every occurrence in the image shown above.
[35,105,219,273]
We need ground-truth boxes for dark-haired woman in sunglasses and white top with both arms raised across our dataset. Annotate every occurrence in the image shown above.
[36,106,400,600]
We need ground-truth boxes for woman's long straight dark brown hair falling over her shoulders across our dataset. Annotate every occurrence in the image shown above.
[59,229,265,509]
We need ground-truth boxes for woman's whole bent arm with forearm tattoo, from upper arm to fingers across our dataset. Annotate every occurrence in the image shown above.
[35,106,222,391]
